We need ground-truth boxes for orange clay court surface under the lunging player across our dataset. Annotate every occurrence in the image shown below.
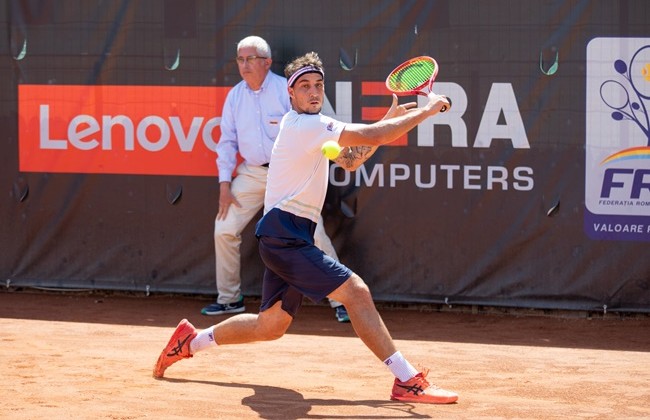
[0,292,650,420]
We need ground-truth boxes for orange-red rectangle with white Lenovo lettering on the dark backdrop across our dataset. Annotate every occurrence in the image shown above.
[18,85,230,176]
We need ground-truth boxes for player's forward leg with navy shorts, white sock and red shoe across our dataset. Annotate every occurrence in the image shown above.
[259,236,458,404]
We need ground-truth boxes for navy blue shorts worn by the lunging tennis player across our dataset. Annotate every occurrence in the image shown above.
[258,236,352,317]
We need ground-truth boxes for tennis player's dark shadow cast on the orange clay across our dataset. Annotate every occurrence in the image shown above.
[161,378,431,420]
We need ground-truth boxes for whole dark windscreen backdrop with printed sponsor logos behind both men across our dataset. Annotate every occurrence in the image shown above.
[0,0,650,312]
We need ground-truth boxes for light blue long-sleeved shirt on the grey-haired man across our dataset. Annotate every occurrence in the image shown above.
[217,71,291,182]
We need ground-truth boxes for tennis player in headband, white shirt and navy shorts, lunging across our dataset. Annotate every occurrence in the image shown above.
[153,52,458,404]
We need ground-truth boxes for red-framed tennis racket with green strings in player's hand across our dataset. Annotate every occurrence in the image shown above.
[386,55,451,112]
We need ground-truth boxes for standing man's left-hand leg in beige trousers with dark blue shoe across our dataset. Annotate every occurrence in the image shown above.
[208,163,268,315]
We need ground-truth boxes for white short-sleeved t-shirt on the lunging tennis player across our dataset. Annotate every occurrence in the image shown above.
[264,110,345,223]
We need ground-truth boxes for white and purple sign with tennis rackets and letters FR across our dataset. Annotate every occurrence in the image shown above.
[585,38,650,241]
